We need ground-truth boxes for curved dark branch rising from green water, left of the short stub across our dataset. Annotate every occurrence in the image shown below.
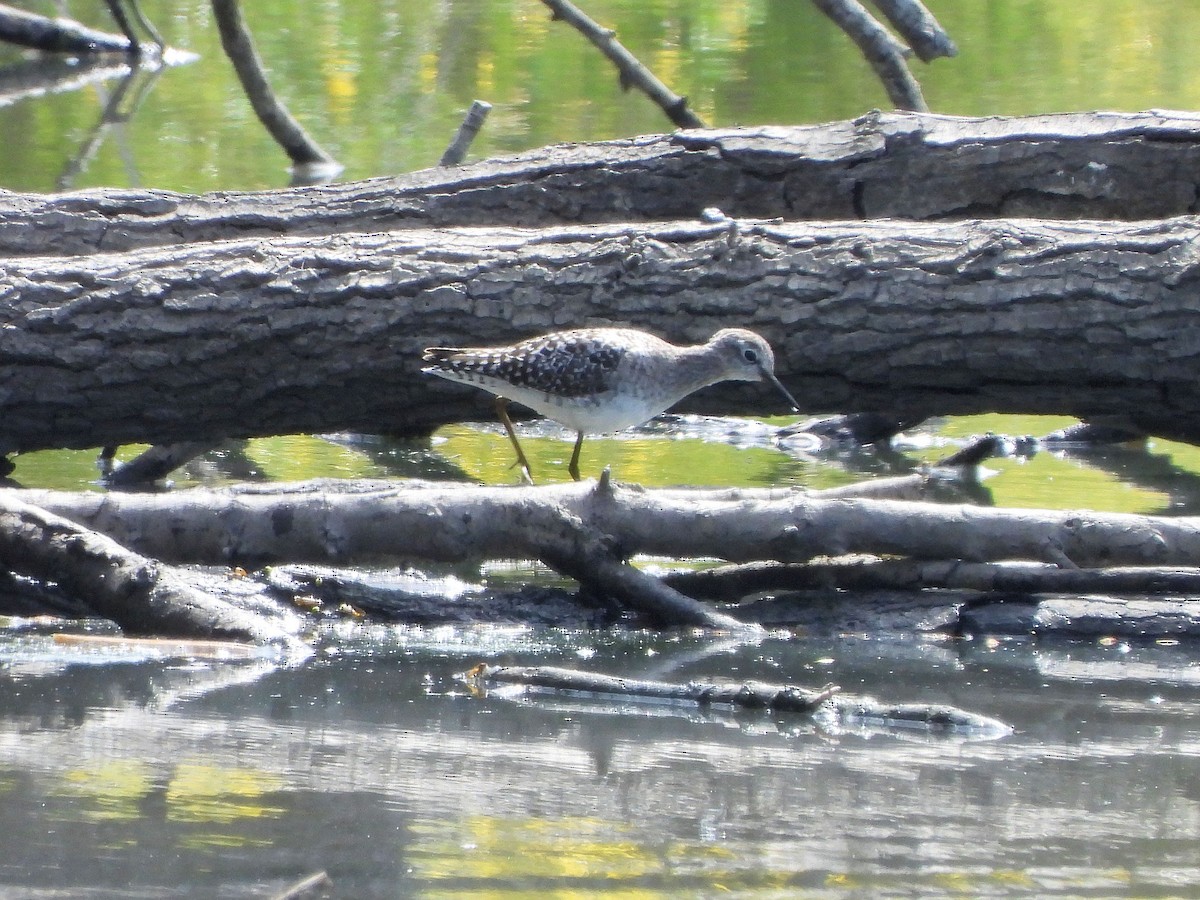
[212,0,341,170]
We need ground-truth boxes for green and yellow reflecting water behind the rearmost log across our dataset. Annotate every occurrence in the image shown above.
[7,0,1200,191]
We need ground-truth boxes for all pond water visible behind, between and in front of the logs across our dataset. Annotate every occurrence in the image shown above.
[0,0,1200,898]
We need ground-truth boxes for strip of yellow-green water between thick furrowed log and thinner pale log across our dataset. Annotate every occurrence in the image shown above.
[13,415,1200,514]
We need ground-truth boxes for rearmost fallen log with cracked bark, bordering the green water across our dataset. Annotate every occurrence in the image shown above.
[7,112,1200,256]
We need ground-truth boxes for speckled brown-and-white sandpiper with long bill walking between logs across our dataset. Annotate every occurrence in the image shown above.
[421,328,797,482]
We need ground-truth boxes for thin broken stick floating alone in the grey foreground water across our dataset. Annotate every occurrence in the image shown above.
[461,662,1013,739]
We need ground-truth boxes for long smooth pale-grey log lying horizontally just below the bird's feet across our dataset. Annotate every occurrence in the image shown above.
[14,481,1200,575]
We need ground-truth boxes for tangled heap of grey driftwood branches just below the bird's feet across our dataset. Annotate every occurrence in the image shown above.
[9,481,1200,642]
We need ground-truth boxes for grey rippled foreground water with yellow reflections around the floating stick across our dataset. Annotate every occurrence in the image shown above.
[0,625,1200,898]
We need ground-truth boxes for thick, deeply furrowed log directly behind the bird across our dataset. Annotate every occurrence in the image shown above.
[0,218,1200,452]
